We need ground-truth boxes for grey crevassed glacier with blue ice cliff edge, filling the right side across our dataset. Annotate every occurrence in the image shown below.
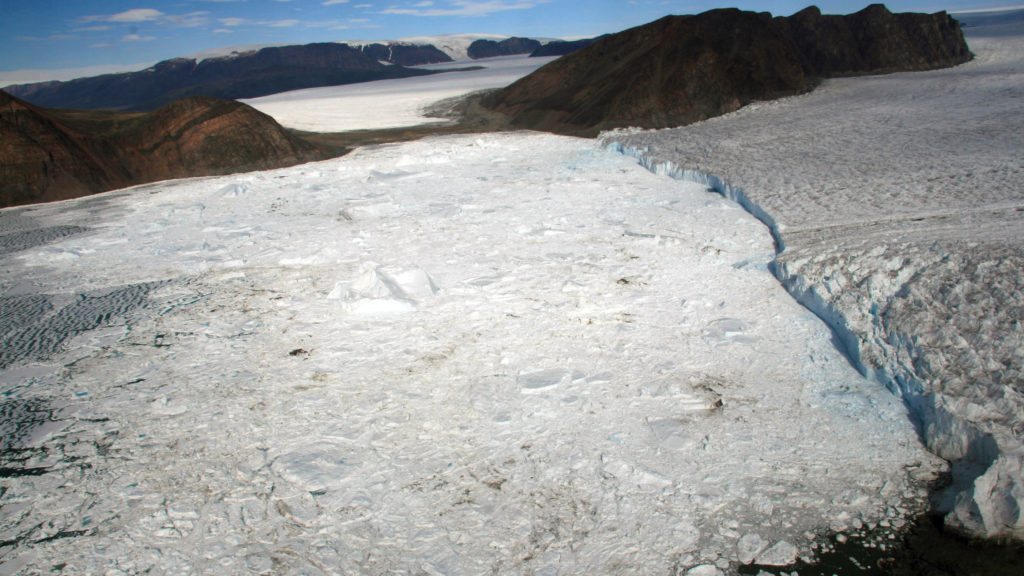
[604,17,1024,538]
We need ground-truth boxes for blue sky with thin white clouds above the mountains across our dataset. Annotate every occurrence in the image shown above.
[0,0,1019,79]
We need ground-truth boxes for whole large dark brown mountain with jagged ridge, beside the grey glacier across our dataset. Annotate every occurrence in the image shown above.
[480,4,971,135]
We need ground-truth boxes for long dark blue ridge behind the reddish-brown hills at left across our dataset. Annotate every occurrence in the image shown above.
[5,43,446,110]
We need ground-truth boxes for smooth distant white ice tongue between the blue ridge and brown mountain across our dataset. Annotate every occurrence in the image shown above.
[241,55,555,132]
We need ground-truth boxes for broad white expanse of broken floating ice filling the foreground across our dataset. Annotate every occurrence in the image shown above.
[0,133,943,574]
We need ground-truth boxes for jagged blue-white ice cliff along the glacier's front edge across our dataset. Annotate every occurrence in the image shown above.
[604,139,1024,536]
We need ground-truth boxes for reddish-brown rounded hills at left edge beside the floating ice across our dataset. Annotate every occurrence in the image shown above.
[0,91,327,207]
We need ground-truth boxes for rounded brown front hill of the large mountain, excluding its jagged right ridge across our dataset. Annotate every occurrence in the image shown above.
[483,8,807,135]
